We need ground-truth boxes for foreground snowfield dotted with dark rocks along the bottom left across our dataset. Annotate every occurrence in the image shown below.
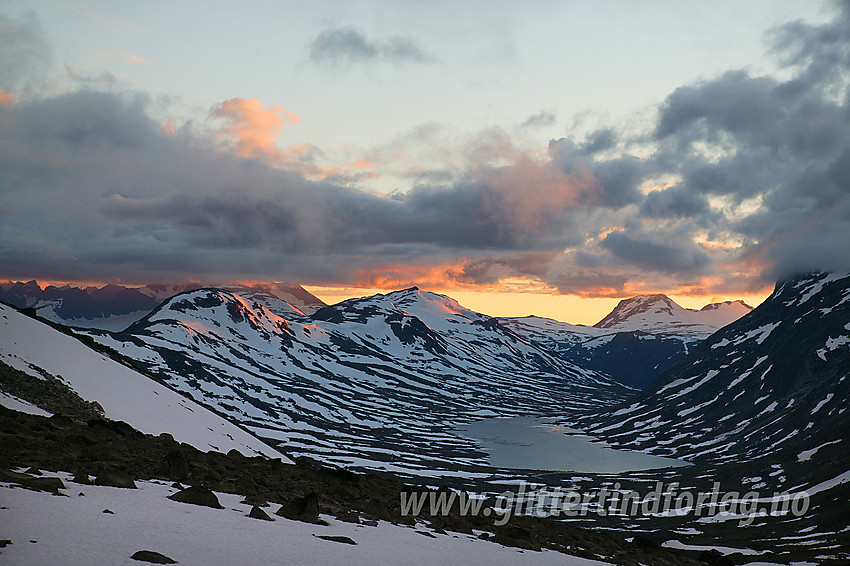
[0,474,607,566]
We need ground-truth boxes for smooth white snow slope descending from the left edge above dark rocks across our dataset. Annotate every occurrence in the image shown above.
[0,304,286,460]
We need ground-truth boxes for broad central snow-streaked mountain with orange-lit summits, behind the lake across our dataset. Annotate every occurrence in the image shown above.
[84,287,631,480]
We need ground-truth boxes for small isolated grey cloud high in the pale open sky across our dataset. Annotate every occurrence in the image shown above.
[307,27,433,65]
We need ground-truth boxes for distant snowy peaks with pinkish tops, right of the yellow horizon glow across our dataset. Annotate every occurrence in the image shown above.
[593,295,753,339]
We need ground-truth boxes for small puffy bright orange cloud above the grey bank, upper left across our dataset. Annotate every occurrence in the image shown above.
[210,98,301,157]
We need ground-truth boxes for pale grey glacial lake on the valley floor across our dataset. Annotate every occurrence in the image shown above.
[456,417,690,474]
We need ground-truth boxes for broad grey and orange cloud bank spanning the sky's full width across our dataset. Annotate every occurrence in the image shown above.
[0,6,850,296]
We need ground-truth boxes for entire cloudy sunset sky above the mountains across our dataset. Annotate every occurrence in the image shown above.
[0,0,850,324]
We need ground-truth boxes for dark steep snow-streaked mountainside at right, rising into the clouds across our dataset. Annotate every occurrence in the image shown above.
[572,273,850,461]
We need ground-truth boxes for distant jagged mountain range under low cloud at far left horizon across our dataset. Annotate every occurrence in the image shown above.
[0,281,327,331]
